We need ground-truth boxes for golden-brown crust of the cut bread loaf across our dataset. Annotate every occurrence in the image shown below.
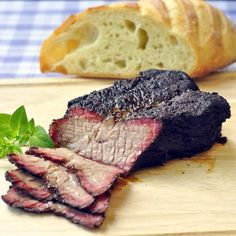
[40,0,236,78]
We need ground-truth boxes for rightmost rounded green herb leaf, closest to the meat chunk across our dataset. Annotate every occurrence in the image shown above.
[29,126,53,148]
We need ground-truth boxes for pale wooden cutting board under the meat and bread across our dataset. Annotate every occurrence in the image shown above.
[0,73,236,236]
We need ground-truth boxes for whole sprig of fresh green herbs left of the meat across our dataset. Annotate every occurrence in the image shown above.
[0,106,53,157]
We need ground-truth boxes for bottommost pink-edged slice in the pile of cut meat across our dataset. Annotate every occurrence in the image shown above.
[2,187,104,228]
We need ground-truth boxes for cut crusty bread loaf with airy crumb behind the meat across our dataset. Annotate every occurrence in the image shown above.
[40,0,236,78]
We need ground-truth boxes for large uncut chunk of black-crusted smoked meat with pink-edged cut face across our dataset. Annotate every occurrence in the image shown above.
[50,70,230,175]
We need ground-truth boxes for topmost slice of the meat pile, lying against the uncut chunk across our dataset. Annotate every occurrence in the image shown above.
[28,147,122,196]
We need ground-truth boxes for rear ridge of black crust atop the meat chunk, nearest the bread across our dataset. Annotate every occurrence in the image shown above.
[66,70,199,120]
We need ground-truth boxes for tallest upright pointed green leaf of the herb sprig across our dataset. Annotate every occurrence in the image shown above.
[10,106,29,136]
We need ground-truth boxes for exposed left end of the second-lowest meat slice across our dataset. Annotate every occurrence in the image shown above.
[5,169,53,201]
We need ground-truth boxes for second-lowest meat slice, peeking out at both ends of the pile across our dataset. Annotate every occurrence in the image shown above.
[6,169,109,214]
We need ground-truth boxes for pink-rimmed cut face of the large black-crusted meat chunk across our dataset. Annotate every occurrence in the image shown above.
[50,108,161,172]
